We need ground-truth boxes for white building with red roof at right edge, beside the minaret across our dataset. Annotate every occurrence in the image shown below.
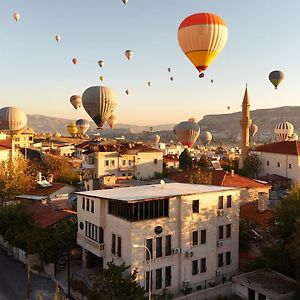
[252,141,300,183]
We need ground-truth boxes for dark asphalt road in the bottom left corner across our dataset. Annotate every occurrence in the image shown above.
[0,249,61,300]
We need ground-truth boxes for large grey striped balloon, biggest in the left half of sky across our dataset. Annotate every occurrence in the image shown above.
[82,86,117,128]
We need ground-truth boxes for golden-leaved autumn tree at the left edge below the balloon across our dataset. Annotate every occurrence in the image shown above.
[0,158,36,201]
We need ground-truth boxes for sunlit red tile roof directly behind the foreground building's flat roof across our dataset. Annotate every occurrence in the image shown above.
[171,169,271,188]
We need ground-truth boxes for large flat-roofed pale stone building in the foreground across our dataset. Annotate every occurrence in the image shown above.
[77,183,242,293]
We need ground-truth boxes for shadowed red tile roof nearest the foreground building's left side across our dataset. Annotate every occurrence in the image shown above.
[25,203,71,228]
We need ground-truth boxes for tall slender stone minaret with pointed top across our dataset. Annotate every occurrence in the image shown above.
[239,84,252,169]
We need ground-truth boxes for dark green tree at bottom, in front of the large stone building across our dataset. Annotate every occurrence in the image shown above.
[88,262,145,300]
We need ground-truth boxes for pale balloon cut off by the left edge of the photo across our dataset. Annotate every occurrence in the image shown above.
[0,106,27,134]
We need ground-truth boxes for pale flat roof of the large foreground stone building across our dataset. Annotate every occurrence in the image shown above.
[76,183,242,201]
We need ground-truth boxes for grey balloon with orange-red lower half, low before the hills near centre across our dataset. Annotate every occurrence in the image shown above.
[174,121,200,148]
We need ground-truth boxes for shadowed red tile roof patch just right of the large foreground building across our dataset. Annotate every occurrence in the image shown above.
[240,201,274,227]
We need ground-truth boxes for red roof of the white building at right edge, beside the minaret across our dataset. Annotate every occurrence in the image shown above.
[254,141,300,156]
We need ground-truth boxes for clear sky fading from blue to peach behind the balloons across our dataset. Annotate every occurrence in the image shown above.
[0,0,300,126]
